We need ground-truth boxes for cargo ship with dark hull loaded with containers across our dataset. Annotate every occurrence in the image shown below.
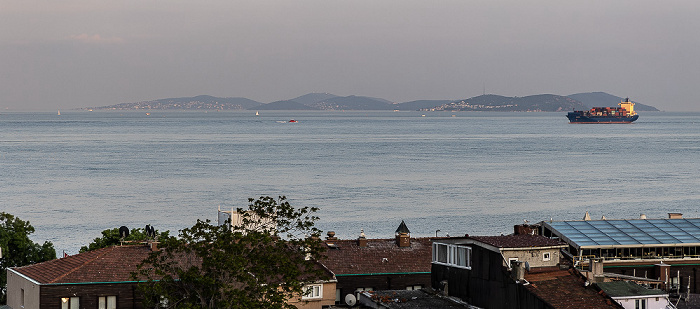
[566,98,639,123]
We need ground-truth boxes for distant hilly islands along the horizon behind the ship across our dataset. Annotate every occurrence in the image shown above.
[83,92,659,112]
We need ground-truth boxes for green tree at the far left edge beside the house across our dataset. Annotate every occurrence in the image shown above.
[0,212,56,304]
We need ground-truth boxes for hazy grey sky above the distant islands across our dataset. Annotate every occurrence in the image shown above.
[0,0,700,111]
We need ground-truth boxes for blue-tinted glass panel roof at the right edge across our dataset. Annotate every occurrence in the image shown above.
[543,218,700,248]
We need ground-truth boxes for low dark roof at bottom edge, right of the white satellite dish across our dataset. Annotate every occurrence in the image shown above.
[360,290,476,309]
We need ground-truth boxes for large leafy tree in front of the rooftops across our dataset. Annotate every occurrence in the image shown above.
[133,196,324,308]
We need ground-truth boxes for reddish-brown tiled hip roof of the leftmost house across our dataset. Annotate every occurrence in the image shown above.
[13,245,151,284]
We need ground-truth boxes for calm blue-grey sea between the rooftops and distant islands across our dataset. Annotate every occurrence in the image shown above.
[0,111,700,254]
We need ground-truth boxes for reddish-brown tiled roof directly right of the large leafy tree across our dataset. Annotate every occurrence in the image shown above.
[321,238,432,275]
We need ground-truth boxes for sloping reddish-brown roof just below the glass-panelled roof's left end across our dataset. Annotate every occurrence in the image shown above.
[525,267,623,309]
